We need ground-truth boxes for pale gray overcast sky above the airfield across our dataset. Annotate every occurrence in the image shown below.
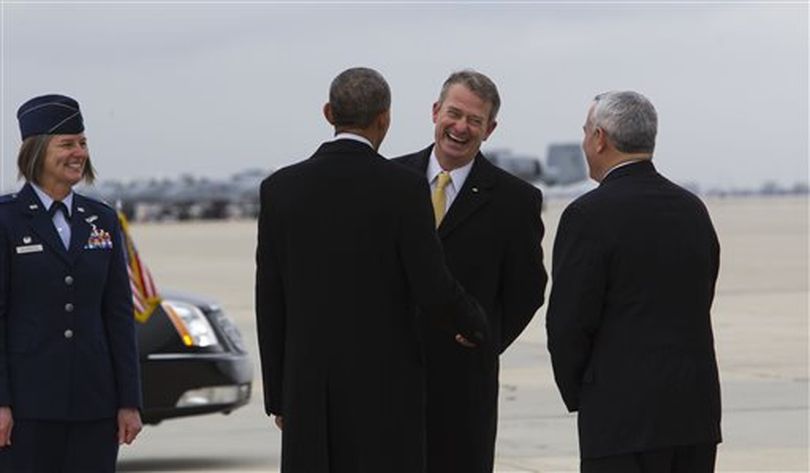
[0,1,809,191]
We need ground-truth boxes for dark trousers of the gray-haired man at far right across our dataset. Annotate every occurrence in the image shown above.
[580,444,717,473]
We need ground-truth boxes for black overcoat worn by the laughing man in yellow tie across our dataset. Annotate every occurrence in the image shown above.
[395,146,547,473]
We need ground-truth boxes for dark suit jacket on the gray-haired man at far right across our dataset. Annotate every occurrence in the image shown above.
[546,161,720,458]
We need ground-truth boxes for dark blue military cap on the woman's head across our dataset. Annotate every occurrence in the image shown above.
[17,94,84,140]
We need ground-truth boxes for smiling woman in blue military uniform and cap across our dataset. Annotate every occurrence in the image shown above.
[0,95,142,473]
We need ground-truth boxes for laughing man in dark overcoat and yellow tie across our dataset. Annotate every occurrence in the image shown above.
[396,70,547,473]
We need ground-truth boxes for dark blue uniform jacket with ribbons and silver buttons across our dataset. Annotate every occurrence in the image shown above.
[0,184,141,421]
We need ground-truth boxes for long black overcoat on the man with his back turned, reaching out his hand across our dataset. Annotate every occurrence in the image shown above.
[256,139,485,473]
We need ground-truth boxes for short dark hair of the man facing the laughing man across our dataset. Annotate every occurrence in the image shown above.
[329,67,391,128]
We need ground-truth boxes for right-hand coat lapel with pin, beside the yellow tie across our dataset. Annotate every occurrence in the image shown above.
[439,153,495,239]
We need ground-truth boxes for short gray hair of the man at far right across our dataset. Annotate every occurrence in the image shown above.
[591,91,658,153]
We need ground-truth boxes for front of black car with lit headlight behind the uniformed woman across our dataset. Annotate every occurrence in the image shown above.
[135,293,253,424]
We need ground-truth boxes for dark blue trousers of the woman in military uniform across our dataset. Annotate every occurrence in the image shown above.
[0,419,118,473]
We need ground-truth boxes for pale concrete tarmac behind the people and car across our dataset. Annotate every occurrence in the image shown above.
[119,197,810,473]
